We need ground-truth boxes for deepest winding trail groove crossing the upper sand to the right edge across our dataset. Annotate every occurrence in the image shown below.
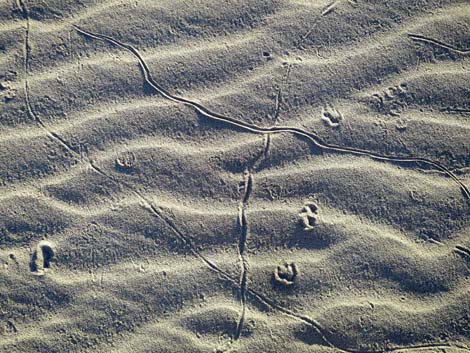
[73,25,470,200]
